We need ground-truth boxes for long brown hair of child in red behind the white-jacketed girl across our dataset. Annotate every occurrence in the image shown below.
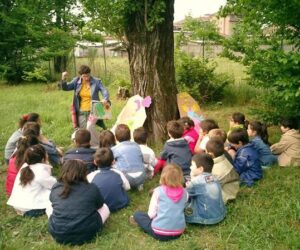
[13,134,39,168]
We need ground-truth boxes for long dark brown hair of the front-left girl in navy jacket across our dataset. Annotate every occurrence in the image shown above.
[58,160,88,198]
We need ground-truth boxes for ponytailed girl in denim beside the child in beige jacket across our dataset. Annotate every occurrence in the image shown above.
[247,121,277,168]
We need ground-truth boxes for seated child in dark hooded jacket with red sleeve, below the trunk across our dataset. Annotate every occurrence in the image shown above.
[154,120,192,178]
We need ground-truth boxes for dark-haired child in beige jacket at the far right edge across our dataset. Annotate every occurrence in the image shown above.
[271,118,300,167]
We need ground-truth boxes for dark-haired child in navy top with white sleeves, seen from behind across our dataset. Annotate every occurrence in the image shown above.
[87,148,130,212]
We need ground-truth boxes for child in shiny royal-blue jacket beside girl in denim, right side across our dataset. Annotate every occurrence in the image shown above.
[228,128,263,187]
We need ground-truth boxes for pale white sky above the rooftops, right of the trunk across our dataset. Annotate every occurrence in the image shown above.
[174,0,226,22]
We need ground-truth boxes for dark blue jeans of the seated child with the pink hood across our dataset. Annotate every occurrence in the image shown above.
[133,212,181,241]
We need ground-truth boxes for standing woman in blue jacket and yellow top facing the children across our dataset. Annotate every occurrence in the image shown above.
[60,65,110,129]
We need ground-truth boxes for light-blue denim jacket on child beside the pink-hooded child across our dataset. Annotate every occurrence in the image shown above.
[185,173,226,225]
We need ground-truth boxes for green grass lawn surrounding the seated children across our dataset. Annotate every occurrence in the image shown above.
[0,81,300,249]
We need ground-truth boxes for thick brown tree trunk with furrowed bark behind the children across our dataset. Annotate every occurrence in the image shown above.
[125,0,178,143]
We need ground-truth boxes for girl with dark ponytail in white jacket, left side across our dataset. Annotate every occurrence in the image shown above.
[7,145,56,217]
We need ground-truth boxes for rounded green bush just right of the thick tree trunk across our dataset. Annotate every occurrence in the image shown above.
[175,52,233,103]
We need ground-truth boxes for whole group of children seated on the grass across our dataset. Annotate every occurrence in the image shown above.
[5,113,300,245]
